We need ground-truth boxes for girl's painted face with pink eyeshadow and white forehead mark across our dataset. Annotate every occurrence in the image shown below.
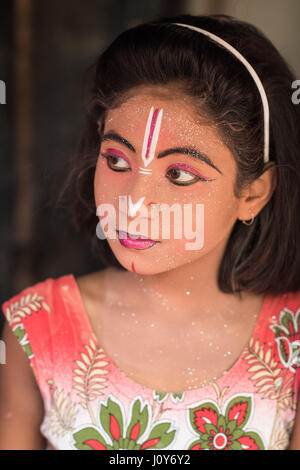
[94,87,239,274]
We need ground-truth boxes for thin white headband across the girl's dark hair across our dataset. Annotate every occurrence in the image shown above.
[173,23,270,163]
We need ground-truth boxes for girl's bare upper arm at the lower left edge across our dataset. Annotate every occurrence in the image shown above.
[0,322,46,450]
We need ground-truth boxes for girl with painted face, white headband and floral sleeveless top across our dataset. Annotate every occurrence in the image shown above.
[0,15,300,450]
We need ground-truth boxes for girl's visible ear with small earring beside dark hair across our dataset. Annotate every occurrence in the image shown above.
[238,162,277,220]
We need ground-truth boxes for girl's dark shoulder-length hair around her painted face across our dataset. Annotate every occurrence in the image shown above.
[56,15,300,295]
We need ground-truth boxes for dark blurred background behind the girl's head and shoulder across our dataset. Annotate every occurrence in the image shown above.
[0,0,300,332]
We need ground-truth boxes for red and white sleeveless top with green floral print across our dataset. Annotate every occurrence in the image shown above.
[2,274,300,450]
